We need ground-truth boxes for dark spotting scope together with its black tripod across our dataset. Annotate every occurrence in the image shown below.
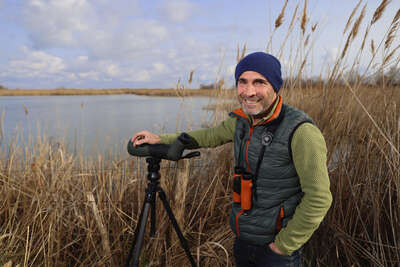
[125,133,200,267]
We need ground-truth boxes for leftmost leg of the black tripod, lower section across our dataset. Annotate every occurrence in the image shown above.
[125,202,151,267]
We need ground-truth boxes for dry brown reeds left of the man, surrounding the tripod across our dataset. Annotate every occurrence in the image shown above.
[0,136,236,266]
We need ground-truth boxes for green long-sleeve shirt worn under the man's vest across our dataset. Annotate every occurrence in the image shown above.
[161,103,332,254]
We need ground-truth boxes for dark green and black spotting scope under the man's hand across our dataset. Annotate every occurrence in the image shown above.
[128,133,200,161]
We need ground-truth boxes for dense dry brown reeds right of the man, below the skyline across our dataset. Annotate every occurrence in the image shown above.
[286,87,400,266]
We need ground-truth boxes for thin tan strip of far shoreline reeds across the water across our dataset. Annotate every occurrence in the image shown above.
[0,88,229,97]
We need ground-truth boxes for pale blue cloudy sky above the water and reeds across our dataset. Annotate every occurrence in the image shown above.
[0,0,400,89]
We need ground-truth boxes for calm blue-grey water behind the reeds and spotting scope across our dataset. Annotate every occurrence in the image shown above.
[0,95,212,155]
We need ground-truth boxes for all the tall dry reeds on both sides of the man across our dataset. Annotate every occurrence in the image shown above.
[0,0,400,266]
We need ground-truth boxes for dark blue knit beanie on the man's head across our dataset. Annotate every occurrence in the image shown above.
[235,52,282,93]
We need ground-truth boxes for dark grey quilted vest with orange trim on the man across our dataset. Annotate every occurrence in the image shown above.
[229,104,314,245]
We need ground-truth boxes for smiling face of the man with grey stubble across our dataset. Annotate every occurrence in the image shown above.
[237,71,276,115]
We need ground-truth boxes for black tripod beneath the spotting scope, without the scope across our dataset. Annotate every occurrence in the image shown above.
[125,157,196,267]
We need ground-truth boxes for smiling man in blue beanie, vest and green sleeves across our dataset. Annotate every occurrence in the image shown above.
[132,52,332,266]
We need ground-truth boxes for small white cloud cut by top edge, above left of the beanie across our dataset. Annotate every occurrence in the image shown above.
[161,0,196,22]
